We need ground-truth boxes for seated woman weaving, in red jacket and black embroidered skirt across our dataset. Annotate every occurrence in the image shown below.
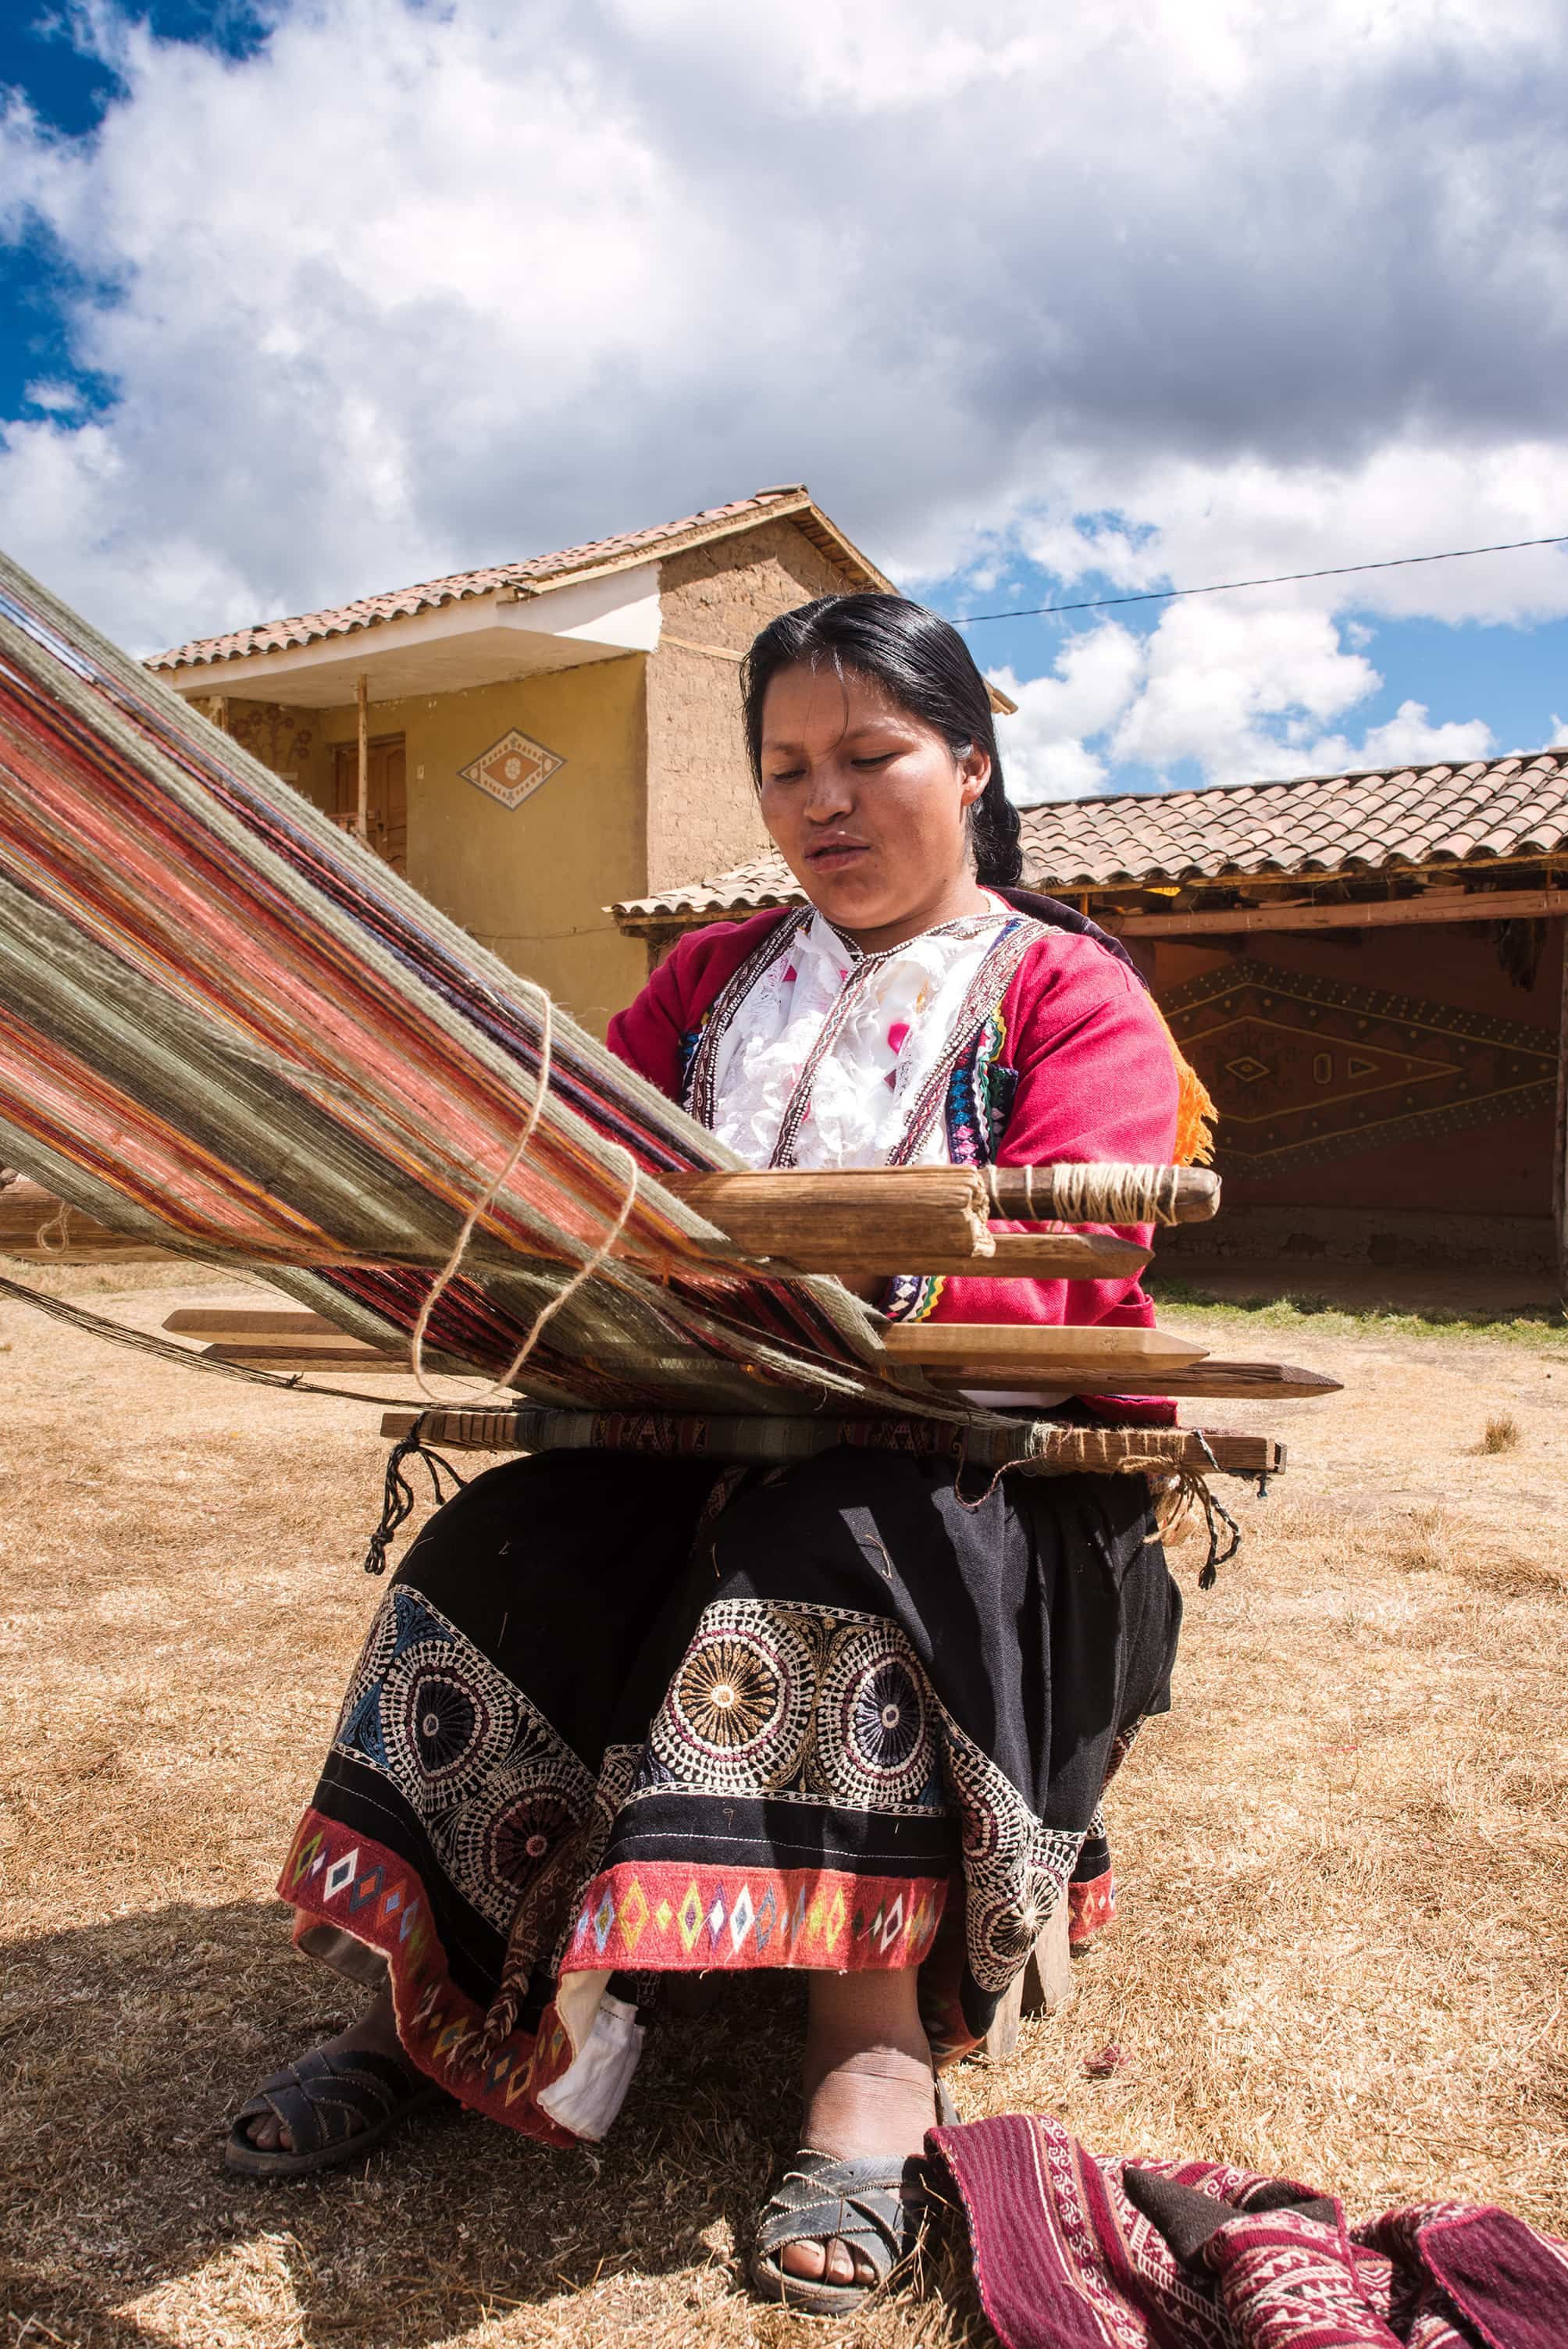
[228,594,1183,2312]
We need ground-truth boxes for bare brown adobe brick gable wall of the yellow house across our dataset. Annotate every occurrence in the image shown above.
[646,522,859,895]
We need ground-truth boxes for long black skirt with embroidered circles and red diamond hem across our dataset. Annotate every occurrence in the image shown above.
[280,1449,1181,2137]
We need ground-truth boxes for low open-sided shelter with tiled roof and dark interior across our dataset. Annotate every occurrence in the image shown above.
[615,750,1568,1287]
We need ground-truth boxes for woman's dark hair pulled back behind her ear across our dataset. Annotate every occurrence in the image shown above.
[739,594,1024,888]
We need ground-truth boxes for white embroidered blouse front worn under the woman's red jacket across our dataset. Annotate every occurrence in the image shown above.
[714,893,1014,1167]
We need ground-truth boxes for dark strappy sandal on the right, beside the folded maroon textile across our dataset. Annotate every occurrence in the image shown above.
[751,2151,932,2316]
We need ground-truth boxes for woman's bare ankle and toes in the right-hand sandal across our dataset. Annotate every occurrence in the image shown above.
[777,1971,936,2286]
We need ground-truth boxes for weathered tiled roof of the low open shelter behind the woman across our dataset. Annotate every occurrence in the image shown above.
[613,747,1568,921]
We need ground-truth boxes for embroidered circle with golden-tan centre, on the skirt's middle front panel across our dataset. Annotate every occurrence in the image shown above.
[650,1602,812,1792]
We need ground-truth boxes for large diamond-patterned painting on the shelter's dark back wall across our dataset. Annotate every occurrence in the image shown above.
[1162,958,1556,1174]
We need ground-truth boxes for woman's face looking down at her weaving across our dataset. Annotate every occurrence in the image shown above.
[763,665,991,954]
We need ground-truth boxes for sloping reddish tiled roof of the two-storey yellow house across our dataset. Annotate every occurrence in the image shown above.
[148,482,889,669]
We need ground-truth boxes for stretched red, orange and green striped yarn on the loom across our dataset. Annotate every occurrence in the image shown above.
[0,559,943,1421]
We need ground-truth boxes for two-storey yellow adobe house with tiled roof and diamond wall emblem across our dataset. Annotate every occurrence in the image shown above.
[148,487,911,1034]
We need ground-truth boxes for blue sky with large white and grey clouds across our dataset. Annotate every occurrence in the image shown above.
[0,0,1568,797]
